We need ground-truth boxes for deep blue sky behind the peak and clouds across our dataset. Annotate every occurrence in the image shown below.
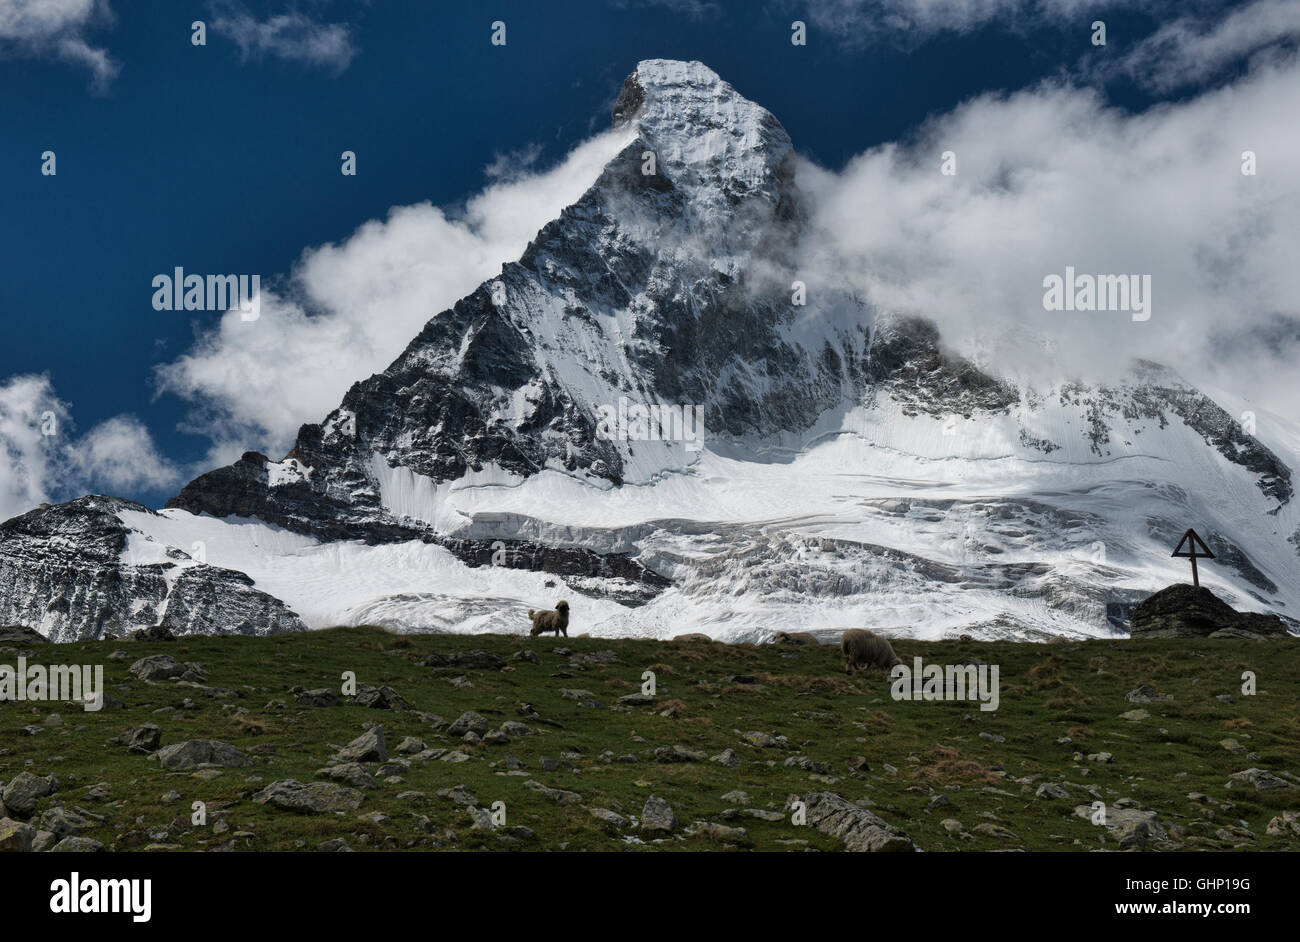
[0,0,1185,505]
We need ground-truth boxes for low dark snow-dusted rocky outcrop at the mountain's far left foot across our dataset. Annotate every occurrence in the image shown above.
[0,496,303,641]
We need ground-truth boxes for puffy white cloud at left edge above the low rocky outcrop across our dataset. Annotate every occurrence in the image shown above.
[0,374,182,520]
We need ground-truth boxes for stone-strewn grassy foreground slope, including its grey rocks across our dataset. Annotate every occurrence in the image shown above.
[0,628,1300,851]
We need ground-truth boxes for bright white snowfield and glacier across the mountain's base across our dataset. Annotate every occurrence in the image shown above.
[121,384,1300,641]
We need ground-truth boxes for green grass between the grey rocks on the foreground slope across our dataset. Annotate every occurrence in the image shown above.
[0,628,1300,851]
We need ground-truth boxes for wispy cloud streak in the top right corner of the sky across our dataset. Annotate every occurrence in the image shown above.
[1099,0,1300,92]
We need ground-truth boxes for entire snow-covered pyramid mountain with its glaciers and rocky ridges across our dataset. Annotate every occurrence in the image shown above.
[0,60,1300,639]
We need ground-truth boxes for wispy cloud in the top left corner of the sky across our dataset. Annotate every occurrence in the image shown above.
[0,0,120,91]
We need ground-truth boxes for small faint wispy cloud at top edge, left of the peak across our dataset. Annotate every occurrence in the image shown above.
[211,0,356,71]
